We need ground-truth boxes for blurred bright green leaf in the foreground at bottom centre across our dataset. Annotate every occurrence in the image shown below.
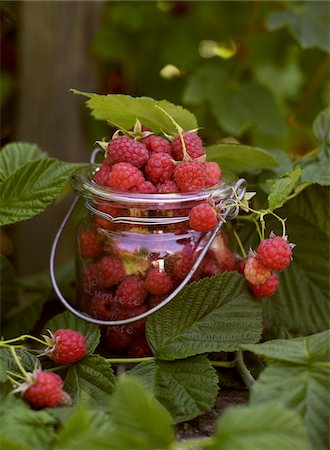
[111,376,174,449]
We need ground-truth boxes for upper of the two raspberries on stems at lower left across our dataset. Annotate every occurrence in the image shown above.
[49,329,86,364]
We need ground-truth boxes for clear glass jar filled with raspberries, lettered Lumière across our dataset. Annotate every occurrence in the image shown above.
[71,166,235,357]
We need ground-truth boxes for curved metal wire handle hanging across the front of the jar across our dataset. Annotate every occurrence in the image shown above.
[50,150,246,325]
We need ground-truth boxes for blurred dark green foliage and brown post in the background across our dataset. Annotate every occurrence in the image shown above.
[0,1,329,274]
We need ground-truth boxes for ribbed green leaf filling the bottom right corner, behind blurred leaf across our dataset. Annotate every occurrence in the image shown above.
[251,362,330,450]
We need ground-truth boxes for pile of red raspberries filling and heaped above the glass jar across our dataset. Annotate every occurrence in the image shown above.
[78,132,294,357]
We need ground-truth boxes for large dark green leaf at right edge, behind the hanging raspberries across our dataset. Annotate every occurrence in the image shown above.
[263,186,330,338]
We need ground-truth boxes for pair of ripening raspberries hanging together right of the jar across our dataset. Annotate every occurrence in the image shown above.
[238,233,294,298]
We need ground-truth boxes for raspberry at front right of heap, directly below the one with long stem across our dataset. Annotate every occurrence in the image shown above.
[174,161,205,192]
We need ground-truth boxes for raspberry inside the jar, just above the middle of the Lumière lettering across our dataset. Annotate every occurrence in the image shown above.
[116,275,148,307]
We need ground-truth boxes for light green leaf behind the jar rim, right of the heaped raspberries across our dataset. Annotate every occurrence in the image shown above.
[206,144,277,174]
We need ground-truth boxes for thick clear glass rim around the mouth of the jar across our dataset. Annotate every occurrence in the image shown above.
[70,164,232,205]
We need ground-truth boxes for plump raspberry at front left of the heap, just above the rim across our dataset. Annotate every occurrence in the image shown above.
[109,163,145,191]
